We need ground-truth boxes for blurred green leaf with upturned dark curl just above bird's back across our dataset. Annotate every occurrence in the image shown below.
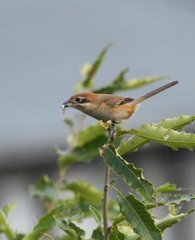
[93,74,168,94]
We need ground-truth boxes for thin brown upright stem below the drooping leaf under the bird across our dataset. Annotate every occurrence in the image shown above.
[103,165,110,240]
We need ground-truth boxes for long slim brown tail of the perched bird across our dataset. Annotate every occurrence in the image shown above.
[130,81,179,106]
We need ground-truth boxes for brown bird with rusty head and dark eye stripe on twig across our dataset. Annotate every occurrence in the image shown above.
[61,81,179,149]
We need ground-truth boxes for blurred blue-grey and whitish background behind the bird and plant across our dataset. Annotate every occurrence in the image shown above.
[0,0,195,240]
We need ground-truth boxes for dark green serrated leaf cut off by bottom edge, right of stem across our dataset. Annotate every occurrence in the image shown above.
[115,188,162,240]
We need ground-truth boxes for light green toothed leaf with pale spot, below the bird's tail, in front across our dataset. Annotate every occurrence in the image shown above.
[129,124,195,150]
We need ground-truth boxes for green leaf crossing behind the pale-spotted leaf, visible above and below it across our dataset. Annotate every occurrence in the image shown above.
[117,115,195,155]
